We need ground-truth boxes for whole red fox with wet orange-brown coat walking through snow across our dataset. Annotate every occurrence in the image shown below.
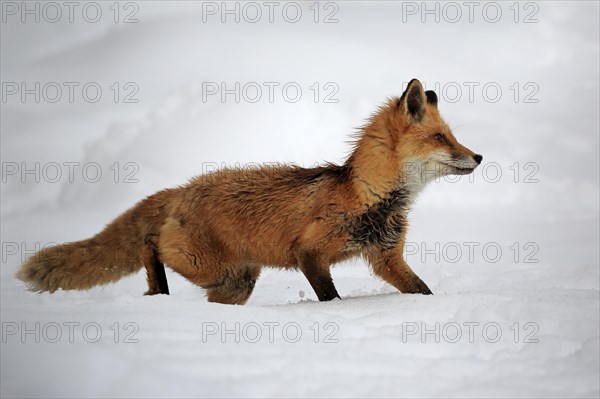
[17,79,483,304]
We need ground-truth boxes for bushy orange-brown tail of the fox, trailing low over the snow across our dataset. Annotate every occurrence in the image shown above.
[17,190,176,292]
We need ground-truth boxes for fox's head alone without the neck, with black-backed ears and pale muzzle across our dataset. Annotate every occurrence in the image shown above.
[388,79,483,183]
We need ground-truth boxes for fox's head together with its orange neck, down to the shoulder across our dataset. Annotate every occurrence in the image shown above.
[347,79,483,203]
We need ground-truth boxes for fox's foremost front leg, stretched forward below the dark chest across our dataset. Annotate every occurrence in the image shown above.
[367,246,433,295]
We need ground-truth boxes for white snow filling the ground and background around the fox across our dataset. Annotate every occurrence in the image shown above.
[0,1,600,397]
